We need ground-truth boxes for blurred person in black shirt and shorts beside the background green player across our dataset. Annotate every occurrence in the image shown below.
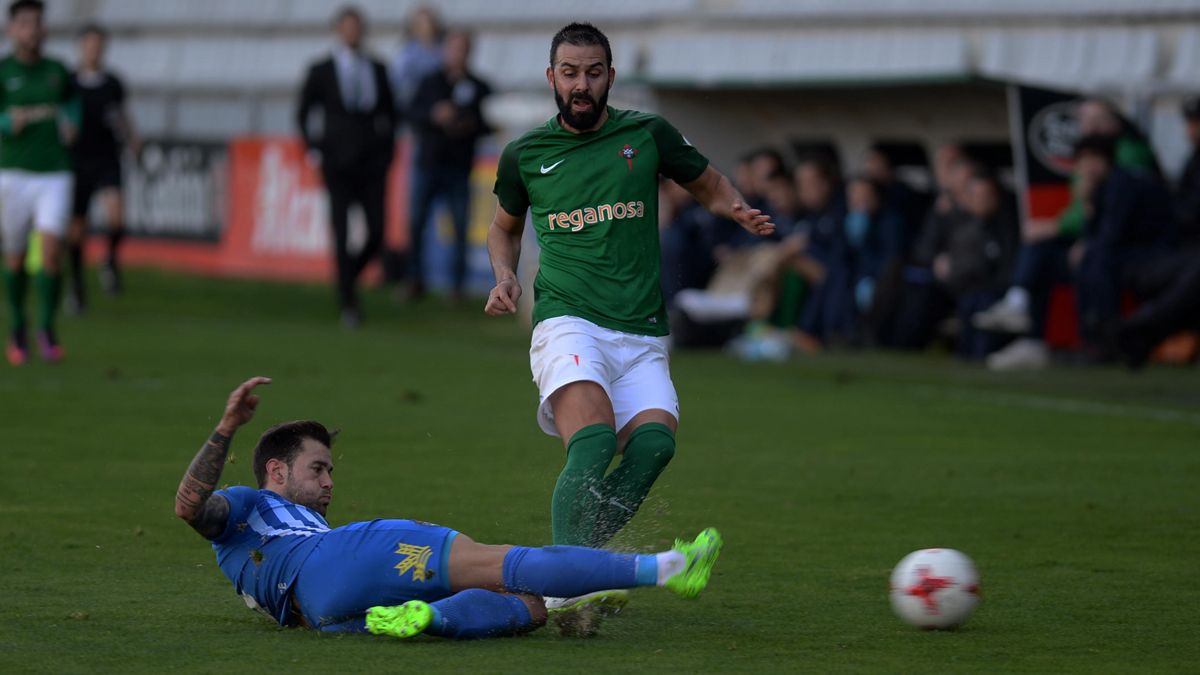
[67,24,140,312]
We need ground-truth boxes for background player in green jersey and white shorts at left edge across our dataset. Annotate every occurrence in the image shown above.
[0,0,79,365]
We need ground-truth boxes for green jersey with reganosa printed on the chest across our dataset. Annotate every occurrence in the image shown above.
[496,107,708,335]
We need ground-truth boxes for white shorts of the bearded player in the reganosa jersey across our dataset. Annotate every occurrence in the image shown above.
[529,316,679,436]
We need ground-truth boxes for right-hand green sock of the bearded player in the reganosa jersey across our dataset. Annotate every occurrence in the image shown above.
[588,422,674,548]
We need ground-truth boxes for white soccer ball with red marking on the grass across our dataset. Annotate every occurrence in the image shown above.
[890,549,979,628]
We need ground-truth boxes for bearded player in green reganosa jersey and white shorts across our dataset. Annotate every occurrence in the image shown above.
[485,23,775,624]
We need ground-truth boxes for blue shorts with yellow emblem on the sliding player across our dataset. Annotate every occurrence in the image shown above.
[293,520,458,632]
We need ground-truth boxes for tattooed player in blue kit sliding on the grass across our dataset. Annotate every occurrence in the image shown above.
[175,377,721,638]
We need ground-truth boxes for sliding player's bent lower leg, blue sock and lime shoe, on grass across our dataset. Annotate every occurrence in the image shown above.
[366,589,546,640]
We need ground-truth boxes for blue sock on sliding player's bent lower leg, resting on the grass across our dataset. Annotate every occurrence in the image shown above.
[425,589,533,640]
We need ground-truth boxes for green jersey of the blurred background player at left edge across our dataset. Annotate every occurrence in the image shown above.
[0,55,79,173]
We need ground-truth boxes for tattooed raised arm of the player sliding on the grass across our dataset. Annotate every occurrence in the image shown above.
[175,377,271,539]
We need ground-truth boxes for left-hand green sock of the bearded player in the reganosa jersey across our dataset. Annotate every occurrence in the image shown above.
[550,424,617,546]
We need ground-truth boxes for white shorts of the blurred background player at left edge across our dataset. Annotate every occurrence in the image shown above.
[0,169,73,253]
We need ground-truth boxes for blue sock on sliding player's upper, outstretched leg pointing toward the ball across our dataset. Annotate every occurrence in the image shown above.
[504,546,658,598]
